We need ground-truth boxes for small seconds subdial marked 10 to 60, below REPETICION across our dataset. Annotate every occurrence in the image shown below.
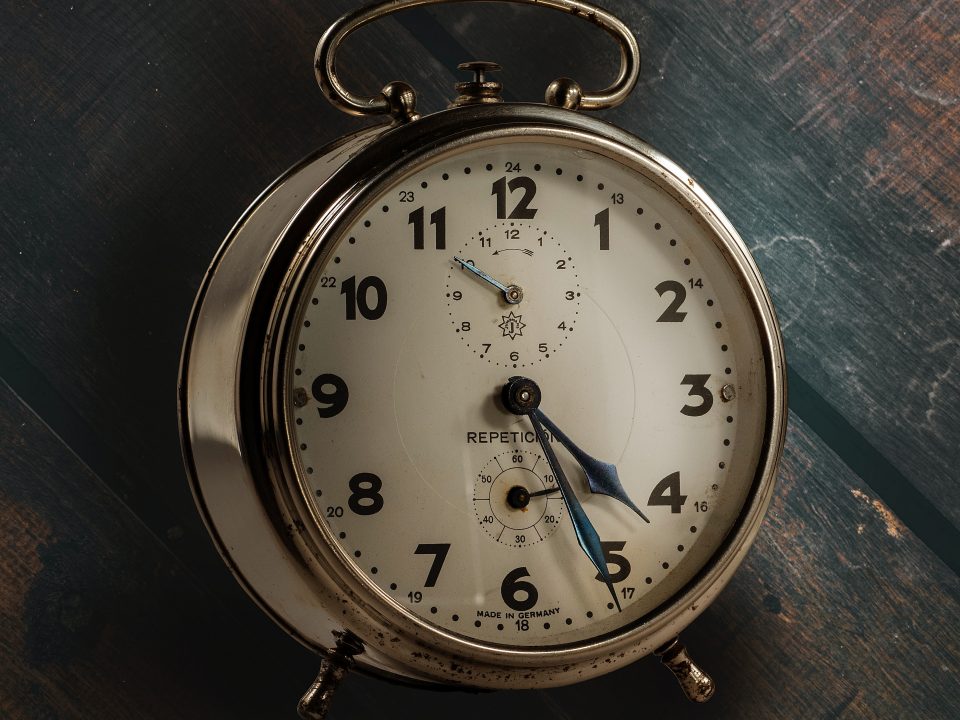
[473,450,563,547]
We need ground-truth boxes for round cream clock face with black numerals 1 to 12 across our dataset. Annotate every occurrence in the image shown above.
[286,139,767,648]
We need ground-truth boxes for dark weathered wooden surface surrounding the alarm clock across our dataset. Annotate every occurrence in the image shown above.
[0,0,960,720]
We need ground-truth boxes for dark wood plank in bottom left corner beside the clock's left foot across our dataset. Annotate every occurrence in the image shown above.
[0,383,315,720]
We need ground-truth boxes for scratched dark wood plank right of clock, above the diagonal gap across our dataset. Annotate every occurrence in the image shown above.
[410,0,960,526]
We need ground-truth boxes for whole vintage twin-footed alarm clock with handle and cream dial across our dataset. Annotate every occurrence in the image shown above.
[179,0,786,718]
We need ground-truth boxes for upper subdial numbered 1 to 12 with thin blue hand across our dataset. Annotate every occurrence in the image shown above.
[445,220,581,369]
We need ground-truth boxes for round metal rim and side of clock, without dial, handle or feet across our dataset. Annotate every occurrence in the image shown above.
[181,105,786,688]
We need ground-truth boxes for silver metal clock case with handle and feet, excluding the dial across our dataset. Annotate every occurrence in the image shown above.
[179,0,786,718]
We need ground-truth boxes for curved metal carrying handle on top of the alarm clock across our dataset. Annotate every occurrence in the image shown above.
[314,0,640,121]
